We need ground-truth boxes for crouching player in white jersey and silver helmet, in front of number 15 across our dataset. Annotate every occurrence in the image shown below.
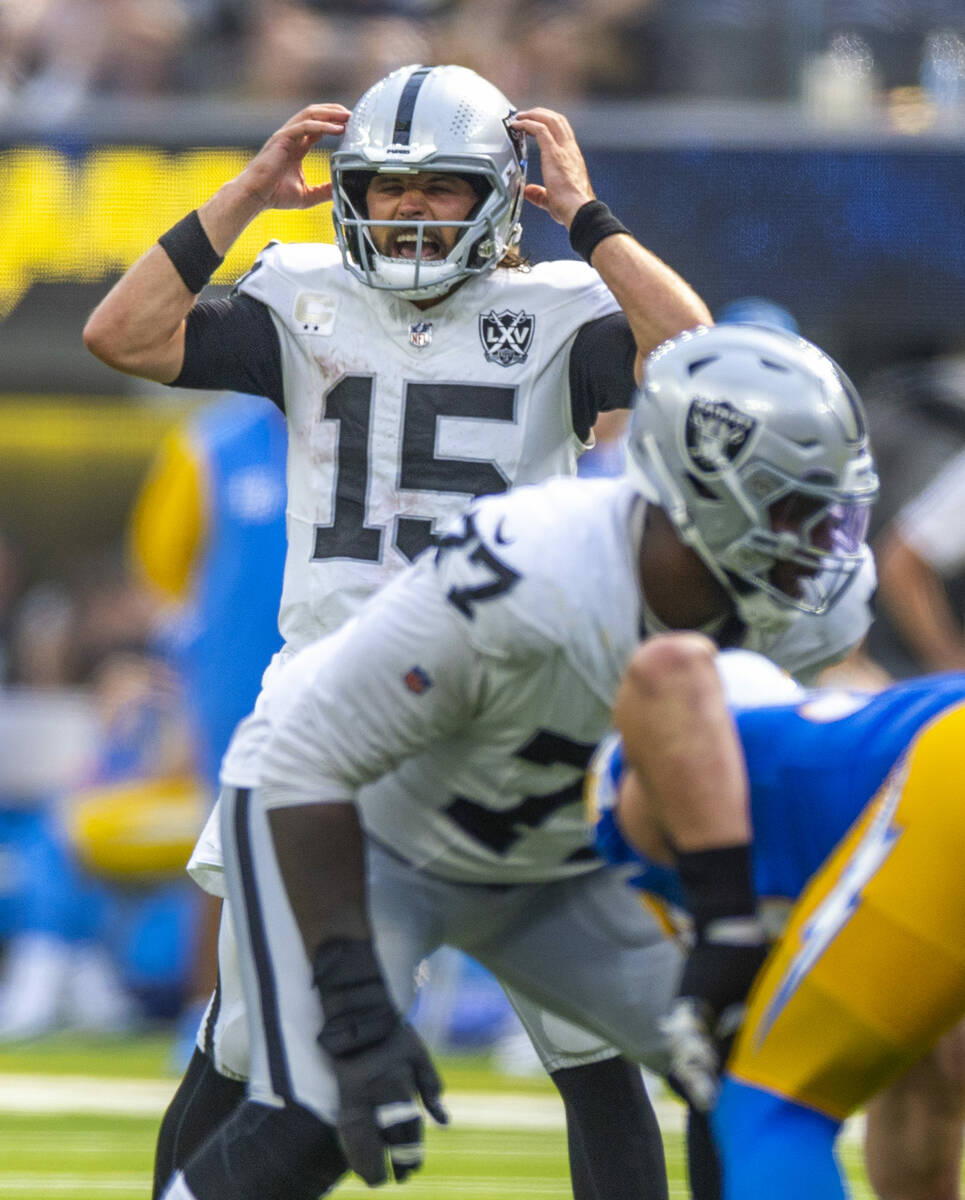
[152,326,877,1200]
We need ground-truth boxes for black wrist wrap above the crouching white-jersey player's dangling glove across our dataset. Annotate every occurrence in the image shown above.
[312,937,400,1058]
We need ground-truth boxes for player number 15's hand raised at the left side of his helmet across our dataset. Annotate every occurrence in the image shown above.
[236,103,352,209]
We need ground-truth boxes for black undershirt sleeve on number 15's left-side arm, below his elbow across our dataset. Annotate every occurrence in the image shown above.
[172,295,284,412]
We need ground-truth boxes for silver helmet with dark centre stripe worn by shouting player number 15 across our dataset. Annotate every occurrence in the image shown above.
[331,66,526,300]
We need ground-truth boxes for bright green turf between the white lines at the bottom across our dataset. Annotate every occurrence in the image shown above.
[0,1037,871,1200]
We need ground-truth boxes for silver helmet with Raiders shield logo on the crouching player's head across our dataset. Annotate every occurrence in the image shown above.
[627,324,877,631]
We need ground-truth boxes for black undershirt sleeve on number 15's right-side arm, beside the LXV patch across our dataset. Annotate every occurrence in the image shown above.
[570,312,636,442]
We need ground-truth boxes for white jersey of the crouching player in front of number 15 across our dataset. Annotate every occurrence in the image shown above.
[241,479,873,883]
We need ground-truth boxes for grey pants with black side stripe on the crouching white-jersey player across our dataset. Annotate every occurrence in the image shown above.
[222,792,682,1122]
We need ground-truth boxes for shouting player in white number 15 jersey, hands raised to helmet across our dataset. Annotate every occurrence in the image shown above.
[85,66,709,1200]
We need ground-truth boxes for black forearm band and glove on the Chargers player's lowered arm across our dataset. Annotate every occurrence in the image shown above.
[660,846,768,1112]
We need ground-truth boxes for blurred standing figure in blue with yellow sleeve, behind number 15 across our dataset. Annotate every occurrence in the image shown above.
[130,392,288,799]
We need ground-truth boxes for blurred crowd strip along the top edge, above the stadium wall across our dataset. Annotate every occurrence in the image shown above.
[0,0,965,118]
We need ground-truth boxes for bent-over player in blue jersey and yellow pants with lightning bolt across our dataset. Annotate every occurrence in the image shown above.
[592,634,965,1200]
